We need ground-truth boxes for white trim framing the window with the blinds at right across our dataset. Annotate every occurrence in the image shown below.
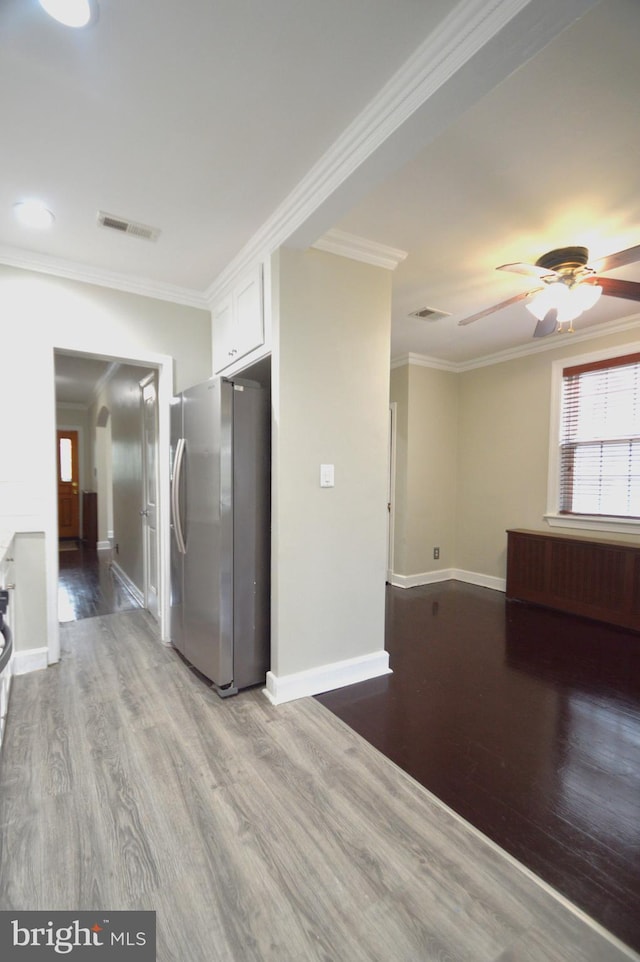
[544,340,640,535]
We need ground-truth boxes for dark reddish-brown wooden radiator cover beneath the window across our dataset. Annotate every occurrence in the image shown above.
[507,529,640,631]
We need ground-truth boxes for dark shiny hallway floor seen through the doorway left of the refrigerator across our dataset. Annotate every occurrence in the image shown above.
[58,541,140,622]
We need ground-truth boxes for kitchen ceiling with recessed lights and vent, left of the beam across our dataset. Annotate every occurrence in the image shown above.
[0,0,451,292]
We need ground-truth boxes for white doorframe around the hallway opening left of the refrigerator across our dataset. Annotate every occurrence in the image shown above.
[50,342,174,664]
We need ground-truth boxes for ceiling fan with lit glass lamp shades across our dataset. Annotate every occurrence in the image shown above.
[458,244,640,337]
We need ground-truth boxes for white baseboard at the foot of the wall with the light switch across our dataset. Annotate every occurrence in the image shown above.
[263,651,391,705]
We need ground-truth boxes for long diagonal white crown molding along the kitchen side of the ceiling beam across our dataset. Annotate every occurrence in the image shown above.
[205,0,552,305]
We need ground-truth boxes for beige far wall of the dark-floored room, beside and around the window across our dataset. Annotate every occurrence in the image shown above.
[391,322,640,579]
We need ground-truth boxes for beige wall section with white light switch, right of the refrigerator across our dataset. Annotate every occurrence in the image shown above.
[272,249,391,676]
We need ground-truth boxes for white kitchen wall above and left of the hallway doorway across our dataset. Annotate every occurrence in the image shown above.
[0,266,211,660]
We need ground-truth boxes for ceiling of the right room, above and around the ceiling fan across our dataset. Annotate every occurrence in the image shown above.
[338,0,640,362]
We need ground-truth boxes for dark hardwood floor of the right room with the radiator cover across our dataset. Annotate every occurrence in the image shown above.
[318,582,640,950]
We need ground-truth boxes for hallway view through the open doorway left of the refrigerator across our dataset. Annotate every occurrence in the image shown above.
[55,351,162,621]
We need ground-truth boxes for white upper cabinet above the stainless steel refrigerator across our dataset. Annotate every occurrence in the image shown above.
[213,265,265,373]
